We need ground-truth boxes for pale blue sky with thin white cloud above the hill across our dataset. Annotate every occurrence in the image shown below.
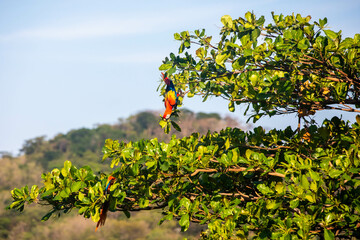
[0,0,360,154]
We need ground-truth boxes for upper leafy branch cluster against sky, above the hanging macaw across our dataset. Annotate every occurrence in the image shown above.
[160,12,360,122]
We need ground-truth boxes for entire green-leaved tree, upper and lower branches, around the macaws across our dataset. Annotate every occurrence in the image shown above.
[9,12,360,239]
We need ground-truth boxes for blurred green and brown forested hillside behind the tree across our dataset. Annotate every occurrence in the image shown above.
[0,110,246,240]
